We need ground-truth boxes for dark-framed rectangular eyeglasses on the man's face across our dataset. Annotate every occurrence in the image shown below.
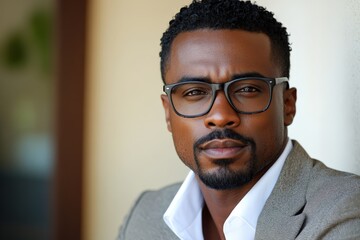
[163,77,289,118]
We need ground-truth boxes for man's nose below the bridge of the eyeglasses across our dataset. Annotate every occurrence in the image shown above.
[204,91,240,128]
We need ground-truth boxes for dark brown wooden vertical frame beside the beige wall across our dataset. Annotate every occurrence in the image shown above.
[52,0,87,240]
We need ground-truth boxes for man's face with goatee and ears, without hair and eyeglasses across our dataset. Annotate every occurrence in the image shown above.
[161,30,296,189]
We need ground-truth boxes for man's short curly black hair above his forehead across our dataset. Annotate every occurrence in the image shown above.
[160,0,291,82]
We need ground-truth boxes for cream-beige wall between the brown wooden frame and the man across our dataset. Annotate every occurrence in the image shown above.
[84,0,188,240]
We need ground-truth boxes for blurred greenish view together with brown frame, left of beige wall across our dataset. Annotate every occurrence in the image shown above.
[0,0,87,240]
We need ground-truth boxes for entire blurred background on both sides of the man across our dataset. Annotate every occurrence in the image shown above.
[0,0,360,240]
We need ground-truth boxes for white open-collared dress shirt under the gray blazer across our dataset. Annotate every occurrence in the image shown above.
[164,140,292,240]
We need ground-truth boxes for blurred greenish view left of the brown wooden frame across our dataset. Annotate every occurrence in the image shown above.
[0,0,56,239]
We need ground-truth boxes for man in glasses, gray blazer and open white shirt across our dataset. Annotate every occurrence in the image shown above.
[119,0,360,240]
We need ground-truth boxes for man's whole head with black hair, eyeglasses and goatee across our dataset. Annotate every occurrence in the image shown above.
[160,0,296,189]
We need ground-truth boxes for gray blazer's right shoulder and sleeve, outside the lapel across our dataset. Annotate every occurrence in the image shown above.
[300,155,360,239]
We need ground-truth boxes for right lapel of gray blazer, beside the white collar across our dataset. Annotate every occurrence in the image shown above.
[255,141,312,240]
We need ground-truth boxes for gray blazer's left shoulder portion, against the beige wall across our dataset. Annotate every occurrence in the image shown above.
[118,183,181,240]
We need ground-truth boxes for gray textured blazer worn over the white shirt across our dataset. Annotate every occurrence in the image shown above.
[118,141,360,240]
